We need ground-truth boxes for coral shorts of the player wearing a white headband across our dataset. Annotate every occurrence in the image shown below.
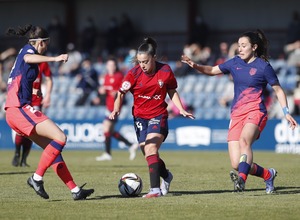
[6,105,48,136]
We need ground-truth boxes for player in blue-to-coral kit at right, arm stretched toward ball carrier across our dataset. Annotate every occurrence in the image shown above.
[182,30,297,194]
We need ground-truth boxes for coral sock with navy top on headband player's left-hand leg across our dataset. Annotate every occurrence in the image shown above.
[35,140,65,176]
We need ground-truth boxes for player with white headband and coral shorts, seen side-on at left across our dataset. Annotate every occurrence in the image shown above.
[5,25,94,200]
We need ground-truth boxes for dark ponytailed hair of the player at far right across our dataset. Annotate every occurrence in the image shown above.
[240,29,269,62]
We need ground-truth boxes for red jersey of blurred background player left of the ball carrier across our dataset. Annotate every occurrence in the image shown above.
[103,72,124,112]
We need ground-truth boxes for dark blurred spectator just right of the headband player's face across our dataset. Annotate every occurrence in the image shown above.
[47,16,66,55]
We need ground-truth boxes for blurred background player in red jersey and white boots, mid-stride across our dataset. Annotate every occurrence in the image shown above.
[96,58,138,161]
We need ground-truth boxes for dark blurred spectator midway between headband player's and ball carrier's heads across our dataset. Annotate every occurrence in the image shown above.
[80,17,97,57]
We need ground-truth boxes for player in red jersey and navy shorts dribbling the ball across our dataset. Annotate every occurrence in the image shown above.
[110,38,194,198]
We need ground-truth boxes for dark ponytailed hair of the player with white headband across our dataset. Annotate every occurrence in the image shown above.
[6,24,49,41]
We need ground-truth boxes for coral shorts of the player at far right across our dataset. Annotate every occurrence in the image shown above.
[227,111,268,141]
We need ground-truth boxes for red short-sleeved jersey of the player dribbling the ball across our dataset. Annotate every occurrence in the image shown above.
[120,62,177,119]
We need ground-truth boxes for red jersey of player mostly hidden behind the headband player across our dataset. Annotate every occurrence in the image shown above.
[31,62,52,106]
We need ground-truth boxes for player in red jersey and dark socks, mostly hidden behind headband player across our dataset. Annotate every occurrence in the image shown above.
[12,62,53,167]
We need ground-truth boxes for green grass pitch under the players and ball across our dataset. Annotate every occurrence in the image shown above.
[0,150,300,219]
